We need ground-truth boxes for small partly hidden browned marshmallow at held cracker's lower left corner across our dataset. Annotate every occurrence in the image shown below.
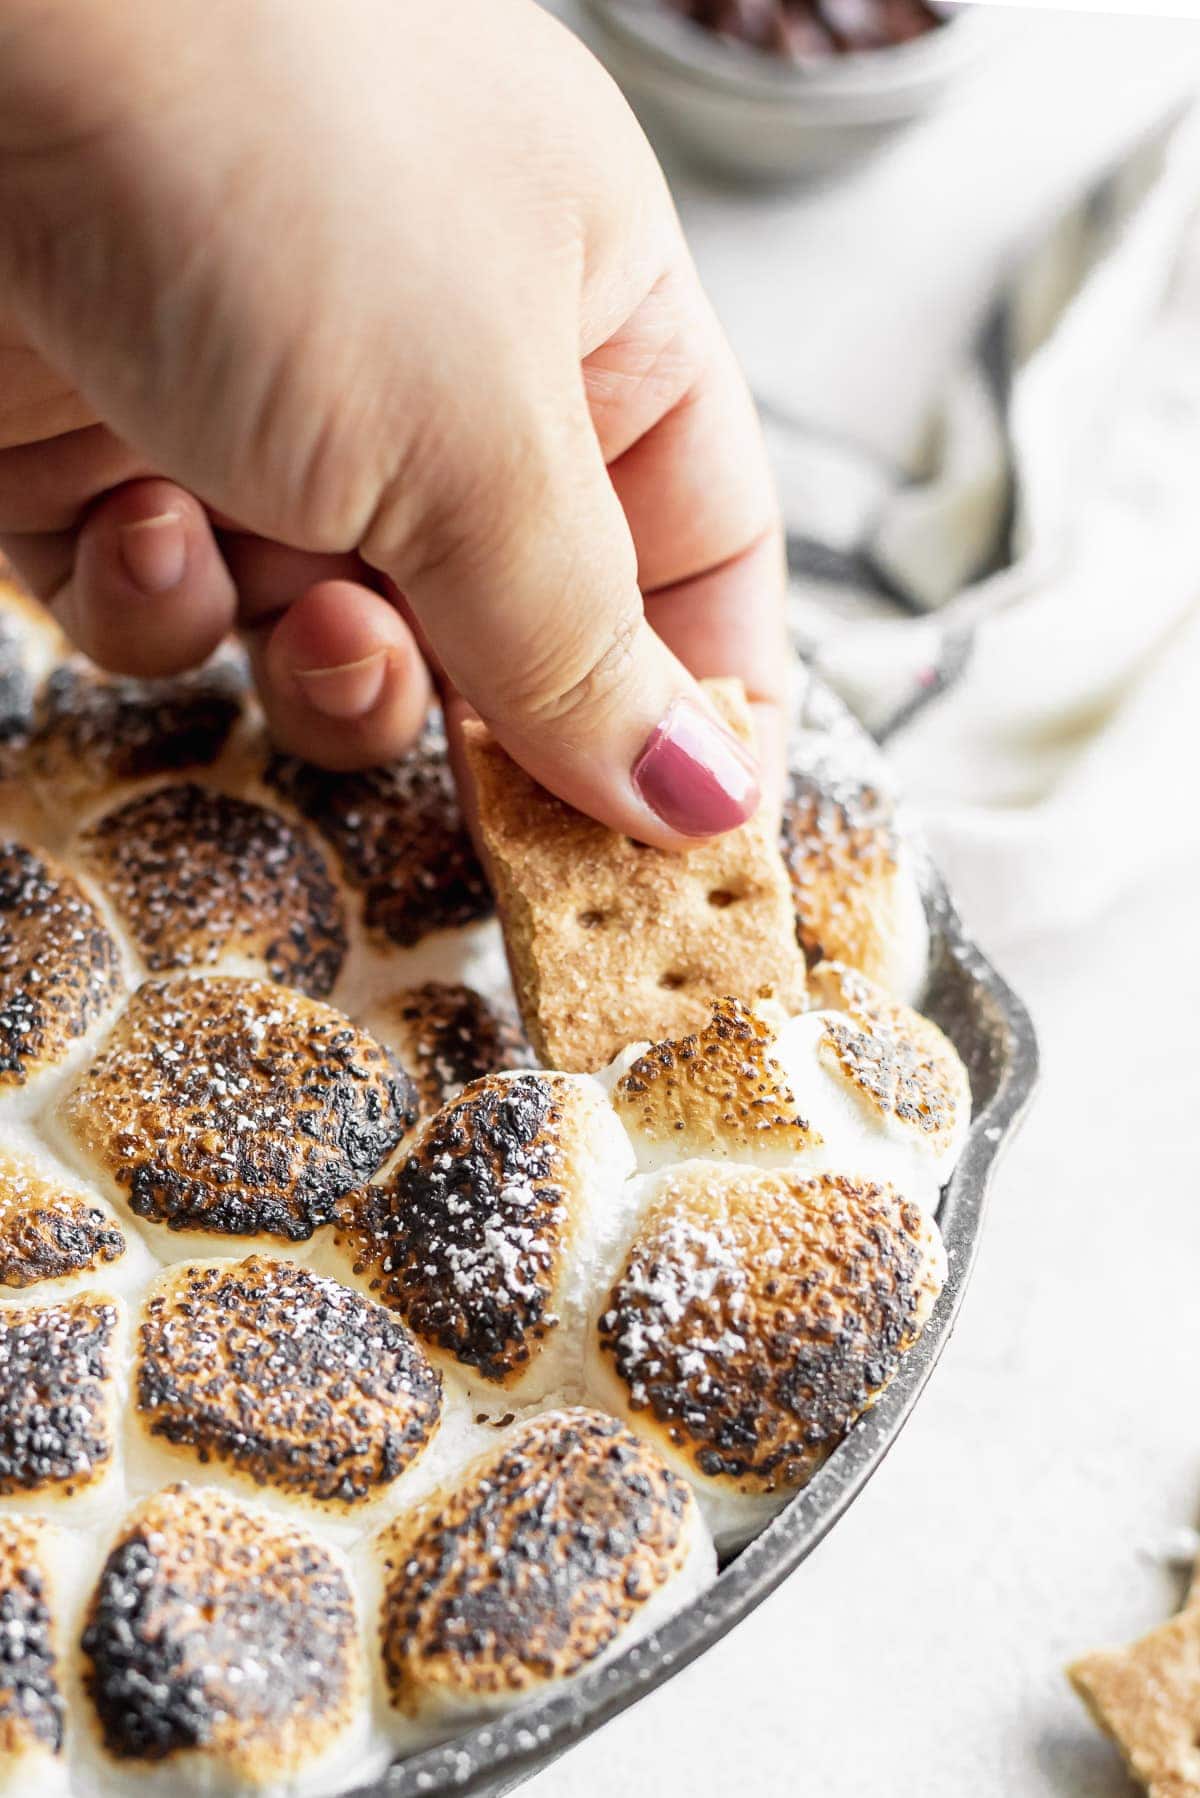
[362,980,533,1117]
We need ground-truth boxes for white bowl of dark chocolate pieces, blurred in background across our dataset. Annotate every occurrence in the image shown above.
[585,0,991,182]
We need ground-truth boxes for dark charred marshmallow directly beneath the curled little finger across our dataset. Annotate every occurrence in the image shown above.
[29,649,246,820]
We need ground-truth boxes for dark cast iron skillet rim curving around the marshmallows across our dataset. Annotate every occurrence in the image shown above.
[347,874,1038,1798]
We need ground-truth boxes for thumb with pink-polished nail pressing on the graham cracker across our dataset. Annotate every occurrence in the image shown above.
[363,392,759,849]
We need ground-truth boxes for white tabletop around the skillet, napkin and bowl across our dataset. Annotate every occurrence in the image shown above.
[527,14,1200,1798]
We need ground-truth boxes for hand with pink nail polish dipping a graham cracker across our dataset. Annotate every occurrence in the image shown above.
[0,0,788,847]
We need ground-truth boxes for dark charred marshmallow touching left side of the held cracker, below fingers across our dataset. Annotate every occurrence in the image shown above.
[266,714,491,949]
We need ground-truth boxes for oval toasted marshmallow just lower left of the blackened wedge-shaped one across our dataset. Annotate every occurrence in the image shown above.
[128,1255,441,1519]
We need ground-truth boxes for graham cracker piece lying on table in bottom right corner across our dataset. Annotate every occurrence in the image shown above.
[1067,1606,1200,1798]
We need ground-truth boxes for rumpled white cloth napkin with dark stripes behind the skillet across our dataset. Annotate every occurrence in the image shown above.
[685,56,1200,948]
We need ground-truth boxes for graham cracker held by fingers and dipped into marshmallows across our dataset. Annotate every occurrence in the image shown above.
[466,681,804,1072]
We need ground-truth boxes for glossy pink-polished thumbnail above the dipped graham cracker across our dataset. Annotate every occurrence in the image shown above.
[633,699,759,836]
